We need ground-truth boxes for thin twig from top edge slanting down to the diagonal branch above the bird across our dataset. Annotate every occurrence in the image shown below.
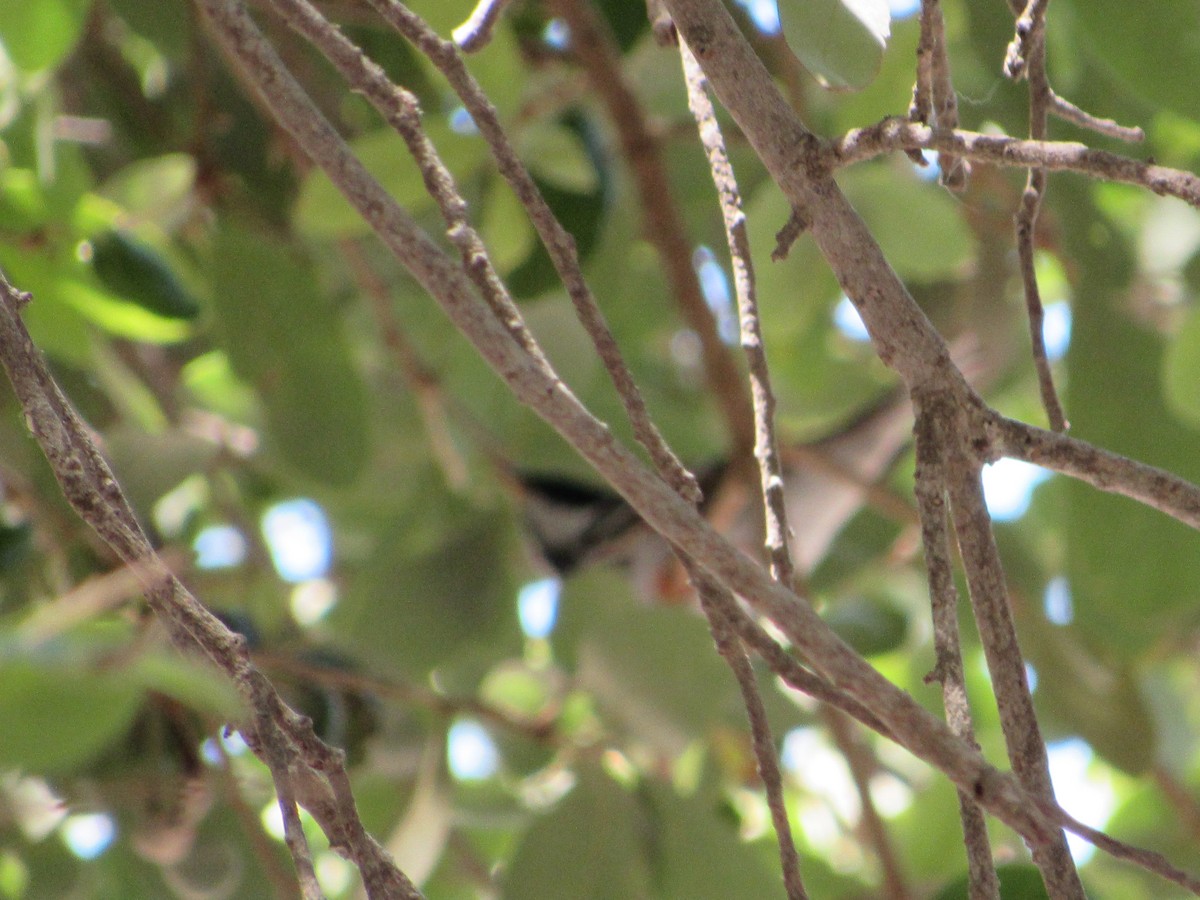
[364,0,700,503]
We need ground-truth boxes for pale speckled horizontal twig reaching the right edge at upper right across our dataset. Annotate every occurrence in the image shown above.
[829,118,1200,208]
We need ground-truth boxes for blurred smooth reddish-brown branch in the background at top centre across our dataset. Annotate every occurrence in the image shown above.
[551,0,755,461]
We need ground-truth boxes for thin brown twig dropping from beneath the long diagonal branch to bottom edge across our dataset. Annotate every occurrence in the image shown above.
[696,571,809,900]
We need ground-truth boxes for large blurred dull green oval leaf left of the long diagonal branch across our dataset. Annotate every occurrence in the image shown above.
[212,222,370,486]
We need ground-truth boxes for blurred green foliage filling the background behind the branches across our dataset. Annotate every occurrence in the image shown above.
[0,0,1200,900]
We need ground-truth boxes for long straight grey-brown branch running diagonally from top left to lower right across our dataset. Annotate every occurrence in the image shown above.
[192,0,1200,877]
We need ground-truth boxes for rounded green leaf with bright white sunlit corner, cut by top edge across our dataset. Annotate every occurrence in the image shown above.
[779,0,892,90]
